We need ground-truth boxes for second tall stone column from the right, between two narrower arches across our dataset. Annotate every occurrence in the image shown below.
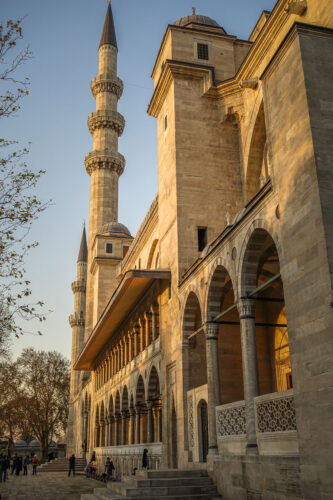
[206,323,220,455]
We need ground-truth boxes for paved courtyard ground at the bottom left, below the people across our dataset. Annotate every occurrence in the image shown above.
[0,470,105,500]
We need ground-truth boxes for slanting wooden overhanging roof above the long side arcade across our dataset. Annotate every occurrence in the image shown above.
[74,269,171,370]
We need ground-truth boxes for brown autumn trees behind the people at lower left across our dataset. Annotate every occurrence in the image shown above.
[0,348,70,458]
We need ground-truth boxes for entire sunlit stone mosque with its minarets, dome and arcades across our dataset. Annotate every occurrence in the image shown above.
[67,0,333,500]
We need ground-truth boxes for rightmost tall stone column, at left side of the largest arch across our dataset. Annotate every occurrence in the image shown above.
[238,298,259,453]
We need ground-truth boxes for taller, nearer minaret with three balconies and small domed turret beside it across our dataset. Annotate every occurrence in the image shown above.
[85,0,132,337]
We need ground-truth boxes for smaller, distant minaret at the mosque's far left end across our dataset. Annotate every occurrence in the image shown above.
[67,227,88,455]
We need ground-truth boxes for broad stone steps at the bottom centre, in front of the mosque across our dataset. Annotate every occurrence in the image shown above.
[81,469,221,500]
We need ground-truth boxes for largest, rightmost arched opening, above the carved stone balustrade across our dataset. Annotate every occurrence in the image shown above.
[241,229,292,395]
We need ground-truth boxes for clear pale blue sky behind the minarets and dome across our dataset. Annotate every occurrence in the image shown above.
[0,0,275,358]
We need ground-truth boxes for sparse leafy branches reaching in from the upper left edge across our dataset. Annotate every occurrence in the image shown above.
[0,19,49,353]
